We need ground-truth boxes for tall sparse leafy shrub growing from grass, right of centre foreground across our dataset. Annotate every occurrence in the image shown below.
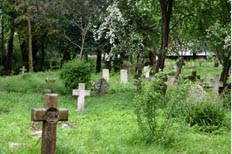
[134,72,170,143]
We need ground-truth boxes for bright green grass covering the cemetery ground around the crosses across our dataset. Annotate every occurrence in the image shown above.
[0,61,230,154]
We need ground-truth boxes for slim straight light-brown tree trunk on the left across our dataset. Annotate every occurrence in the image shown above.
[27,14,33,72]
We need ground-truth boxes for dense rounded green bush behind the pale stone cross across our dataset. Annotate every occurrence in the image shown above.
[60,60,92,89]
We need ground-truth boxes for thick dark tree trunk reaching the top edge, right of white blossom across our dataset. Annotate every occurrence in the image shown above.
[156,0,174,72]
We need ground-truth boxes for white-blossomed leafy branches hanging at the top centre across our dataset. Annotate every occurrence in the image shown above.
[94,2,143,57]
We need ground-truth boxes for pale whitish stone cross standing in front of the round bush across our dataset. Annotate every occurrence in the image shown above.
[72,83,90,112]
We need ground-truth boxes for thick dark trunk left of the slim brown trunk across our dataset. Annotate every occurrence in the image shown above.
[5,27,14,75]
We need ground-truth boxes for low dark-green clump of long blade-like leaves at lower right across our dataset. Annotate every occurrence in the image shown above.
[186,100,225,132]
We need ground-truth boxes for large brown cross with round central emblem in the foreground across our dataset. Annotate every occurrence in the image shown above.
[31,94,68,154]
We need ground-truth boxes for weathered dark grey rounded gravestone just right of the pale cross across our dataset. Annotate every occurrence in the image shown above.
[93,78,109,96]
